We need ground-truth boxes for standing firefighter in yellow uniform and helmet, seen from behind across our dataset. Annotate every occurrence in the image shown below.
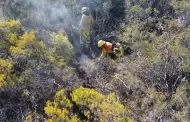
[79,7,94,44]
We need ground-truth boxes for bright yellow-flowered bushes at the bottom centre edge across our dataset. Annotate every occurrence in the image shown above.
[44,87,132,122]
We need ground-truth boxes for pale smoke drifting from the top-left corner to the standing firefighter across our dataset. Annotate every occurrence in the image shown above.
[0,0,81,30]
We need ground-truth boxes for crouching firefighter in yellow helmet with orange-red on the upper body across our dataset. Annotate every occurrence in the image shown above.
[98,40,124,59]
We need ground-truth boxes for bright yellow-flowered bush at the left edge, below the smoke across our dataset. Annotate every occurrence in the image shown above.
[0,20,46,86]
